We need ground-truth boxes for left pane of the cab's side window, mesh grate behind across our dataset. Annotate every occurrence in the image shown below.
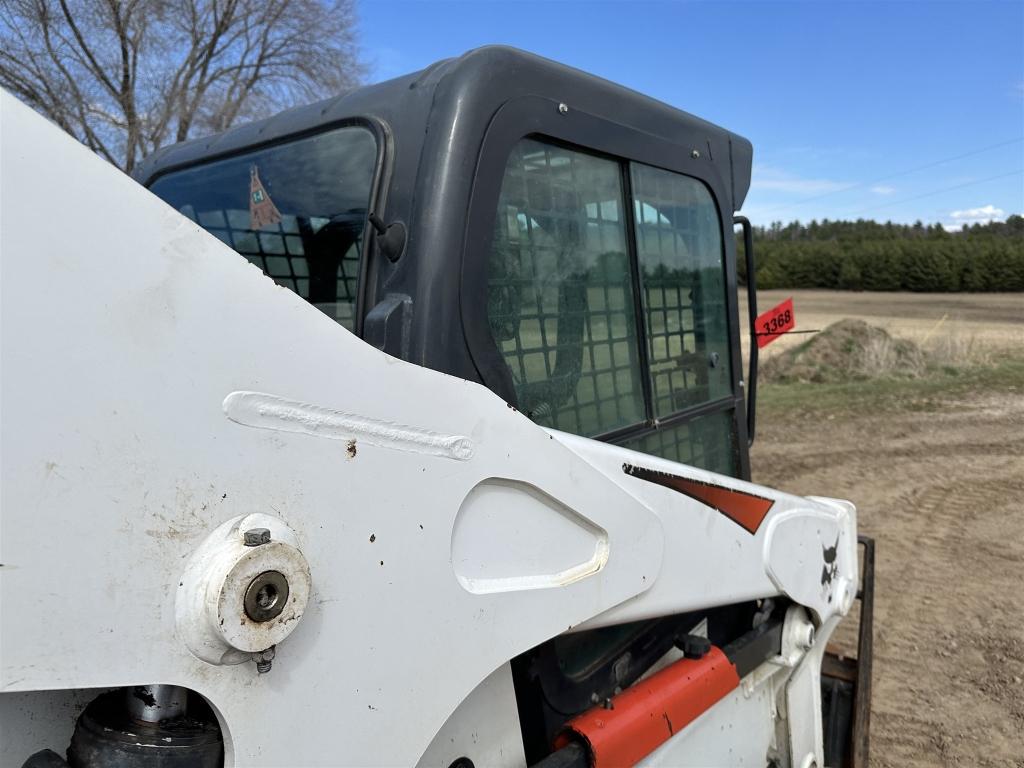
[487,139,645,435]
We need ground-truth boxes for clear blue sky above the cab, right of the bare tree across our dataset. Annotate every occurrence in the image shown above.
[359,0,1024,226]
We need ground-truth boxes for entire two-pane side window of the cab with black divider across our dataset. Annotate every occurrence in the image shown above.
[487,137,736,473]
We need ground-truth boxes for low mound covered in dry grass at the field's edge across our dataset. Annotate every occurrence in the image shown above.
[758,318,926,383]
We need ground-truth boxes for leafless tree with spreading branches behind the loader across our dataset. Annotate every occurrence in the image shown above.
[0,0,362,172]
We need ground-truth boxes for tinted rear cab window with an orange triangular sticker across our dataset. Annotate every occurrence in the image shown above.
[152,126,377,331]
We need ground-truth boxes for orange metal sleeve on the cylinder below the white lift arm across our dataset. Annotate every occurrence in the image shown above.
[555,647,739,768]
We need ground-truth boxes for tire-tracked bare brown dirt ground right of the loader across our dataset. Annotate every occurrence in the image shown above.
[752,294,1024,768]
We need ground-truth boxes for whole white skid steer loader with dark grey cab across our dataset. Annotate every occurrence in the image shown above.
[0,47,873,768]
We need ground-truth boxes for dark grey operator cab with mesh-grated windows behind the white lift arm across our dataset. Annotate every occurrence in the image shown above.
[137,47,757,761]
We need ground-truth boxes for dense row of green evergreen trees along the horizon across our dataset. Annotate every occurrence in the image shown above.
[737,216,1024,293]
